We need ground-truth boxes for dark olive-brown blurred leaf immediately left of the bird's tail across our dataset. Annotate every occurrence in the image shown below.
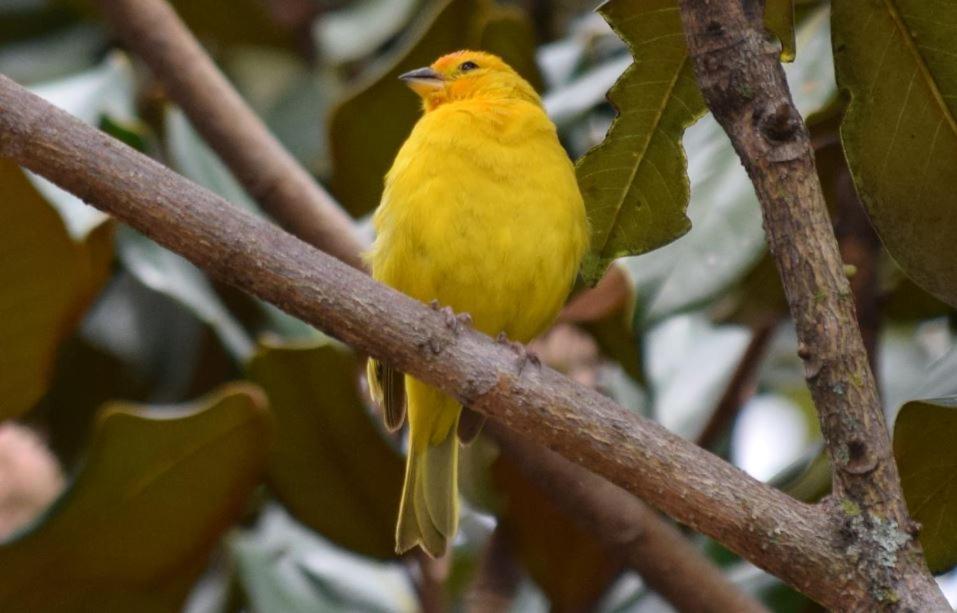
[248,341,404,559]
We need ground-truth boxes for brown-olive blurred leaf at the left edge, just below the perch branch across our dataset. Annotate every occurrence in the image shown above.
[0,160,112,419]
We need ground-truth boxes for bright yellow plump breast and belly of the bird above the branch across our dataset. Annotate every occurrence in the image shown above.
[369,100,588,342]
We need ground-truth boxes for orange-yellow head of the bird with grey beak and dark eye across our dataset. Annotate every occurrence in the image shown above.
[399,51,541,111]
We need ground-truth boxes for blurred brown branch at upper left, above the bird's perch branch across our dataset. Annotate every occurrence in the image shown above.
[100,0,362,268]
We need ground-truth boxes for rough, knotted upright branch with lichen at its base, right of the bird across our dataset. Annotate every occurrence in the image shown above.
[680,0,947,611]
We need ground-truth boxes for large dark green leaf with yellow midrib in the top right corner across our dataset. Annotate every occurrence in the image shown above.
[832,0,957,305]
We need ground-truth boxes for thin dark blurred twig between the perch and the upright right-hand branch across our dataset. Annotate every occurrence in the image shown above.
[698,317,777,449]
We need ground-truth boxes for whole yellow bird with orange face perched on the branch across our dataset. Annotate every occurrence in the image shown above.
[366,51,588,556]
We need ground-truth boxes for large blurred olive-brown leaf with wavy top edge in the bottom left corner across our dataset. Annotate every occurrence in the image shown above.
[0,385,270,613]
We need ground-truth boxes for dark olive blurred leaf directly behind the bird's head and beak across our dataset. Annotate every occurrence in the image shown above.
[329,0,537,216]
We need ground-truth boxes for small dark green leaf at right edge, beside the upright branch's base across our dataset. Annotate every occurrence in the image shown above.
[894,396,957,573]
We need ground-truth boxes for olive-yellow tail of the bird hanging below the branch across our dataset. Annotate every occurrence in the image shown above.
[395,377,461,557]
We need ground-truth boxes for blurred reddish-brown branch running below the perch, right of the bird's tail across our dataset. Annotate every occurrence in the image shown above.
[490,423,767,613]
